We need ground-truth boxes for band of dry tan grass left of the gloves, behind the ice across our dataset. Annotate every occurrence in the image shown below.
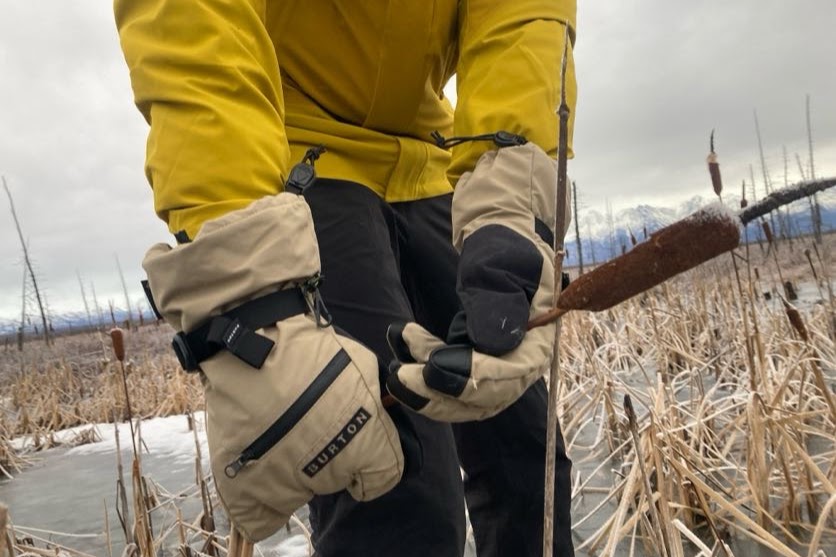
[0,325,203,438]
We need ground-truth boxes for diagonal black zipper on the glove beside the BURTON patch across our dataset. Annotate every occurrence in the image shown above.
[224,349,351,478]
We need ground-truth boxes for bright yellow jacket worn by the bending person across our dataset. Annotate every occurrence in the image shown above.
[115,0,576,237]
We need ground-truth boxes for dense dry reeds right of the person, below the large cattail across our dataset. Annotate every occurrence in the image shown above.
[561,233,836,556]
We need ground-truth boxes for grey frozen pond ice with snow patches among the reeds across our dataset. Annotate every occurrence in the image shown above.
[0,414,836,557]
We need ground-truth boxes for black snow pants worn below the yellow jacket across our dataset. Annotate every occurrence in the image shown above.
[306,179,573,557]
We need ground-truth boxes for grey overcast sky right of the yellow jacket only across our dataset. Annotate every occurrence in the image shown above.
[570,0,836,210]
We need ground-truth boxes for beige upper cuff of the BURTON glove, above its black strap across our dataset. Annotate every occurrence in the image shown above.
[142,193,320,331]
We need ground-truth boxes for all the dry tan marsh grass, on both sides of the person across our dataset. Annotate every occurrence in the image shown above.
[0,232,836,557]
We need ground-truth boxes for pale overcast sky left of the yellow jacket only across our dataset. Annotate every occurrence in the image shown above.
[0,1,171,318]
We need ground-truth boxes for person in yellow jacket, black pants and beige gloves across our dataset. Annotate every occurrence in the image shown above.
[114,0,576,557]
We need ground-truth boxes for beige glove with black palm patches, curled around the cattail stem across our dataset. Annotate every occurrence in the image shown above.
[387,143,565,422]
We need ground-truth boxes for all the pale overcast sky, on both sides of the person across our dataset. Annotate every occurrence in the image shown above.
[0,0,836,322]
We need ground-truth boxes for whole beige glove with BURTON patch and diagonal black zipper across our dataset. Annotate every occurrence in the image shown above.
[143,193,404,542]
